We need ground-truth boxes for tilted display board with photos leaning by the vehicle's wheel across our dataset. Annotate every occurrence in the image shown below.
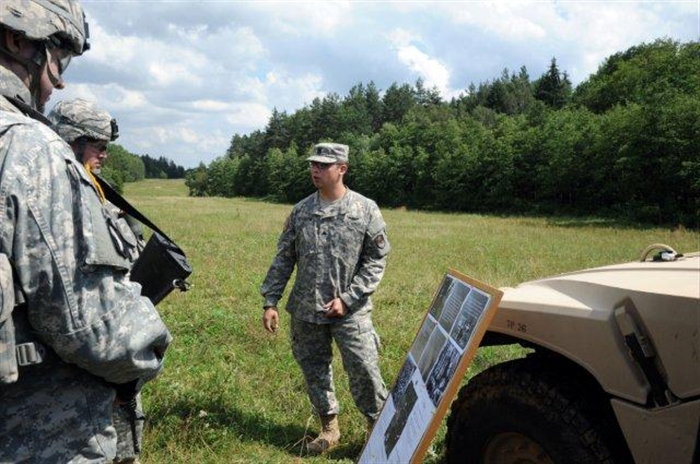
[357,271,503,464]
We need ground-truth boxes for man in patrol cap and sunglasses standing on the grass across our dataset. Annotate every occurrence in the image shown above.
[260,143,390,454]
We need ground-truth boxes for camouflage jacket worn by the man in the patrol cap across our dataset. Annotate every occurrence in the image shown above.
[260,189,391,324]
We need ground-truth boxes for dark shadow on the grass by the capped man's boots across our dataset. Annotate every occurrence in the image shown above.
[147,397,364,460]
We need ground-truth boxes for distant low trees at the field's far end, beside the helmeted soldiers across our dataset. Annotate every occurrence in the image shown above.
[101,143,185,193]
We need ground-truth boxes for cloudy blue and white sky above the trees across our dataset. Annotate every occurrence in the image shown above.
[56,0,700,168]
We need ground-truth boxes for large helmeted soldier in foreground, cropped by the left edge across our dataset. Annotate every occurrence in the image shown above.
[0,0,171,463]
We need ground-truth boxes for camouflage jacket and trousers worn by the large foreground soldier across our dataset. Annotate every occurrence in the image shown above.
[0,67,171,462]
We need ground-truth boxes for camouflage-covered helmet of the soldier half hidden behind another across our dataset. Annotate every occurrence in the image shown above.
[48,98,119,143]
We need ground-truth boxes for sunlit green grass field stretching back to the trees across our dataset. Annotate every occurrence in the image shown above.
[125,180,700,464]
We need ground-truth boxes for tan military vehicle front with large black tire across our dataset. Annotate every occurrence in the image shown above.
[446,244,700,464]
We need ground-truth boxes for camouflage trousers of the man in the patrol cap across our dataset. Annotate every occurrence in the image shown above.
[291,316,388,419]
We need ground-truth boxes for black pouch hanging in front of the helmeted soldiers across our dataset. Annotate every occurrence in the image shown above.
[131,232,192,305]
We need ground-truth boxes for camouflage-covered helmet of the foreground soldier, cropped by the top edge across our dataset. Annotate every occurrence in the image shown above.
[0,0,90,55]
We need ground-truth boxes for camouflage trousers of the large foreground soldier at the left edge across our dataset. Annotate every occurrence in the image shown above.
[0,361,116,463]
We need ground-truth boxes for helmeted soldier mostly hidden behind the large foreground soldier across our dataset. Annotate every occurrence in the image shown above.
[48,98,145,464]
